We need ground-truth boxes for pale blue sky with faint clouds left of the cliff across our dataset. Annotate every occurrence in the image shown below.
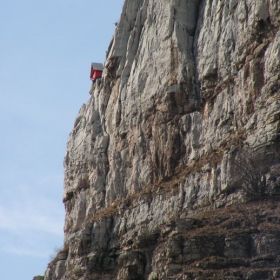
[0,0,123,280]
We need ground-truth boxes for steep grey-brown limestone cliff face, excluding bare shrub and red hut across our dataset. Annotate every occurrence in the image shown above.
[42,0,280,280]
